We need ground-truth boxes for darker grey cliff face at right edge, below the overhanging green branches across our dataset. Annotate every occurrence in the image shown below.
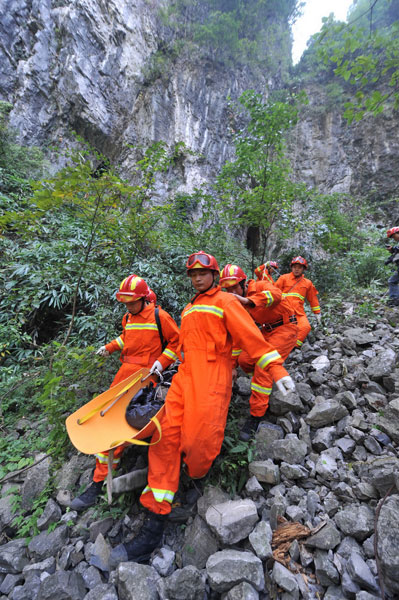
[290,86,399,201]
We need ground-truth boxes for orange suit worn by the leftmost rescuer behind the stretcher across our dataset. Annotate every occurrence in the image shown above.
[93,304,179,481]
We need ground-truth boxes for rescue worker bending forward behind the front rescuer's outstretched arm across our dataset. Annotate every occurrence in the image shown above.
[219,264,298,441]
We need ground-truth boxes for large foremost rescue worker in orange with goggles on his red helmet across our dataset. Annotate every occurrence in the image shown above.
[110,251,292,566]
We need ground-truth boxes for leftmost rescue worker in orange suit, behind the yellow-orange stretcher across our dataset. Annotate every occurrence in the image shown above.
[70,275,179,511]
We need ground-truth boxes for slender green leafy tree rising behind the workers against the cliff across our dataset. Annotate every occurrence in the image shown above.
[217,90,305,268]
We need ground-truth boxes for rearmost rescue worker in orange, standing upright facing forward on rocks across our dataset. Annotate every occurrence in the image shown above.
[275,256,321,348]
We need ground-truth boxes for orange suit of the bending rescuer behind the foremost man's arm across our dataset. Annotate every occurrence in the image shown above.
[233,279,298,417]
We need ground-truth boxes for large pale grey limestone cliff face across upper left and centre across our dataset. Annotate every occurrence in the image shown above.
[0,0,272,191]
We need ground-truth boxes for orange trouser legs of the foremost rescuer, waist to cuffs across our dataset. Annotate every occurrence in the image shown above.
[140,350,231,514]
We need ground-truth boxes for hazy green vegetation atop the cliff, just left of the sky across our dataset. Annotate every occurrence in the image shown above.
[161,0,299,72]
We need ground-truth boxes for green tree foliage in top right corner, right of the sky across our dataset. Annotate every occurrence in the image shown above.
[299,0,399,123]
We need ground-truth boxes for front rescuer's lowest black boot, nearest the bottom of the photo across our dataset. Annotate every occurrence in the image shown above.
[109,513,166,569]
